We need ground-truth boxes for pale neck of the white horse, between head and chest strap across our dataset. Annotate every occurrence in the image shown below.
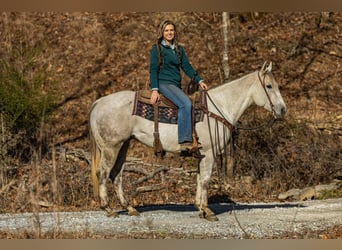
[208,72,258,125]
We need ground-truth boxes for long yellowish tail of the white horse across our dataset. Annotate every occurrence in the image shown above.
[90,130,101,198]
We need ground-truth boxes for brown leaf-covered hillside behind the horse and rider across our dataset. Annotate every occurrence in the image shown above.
[0,12,342,219]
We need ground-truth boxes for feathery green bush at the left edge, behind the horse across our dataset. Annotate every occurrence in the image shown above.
[0,39,55,159]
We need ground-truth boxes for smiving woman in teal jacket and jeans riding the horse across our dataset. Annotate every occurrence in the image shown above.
[150,20,208,151]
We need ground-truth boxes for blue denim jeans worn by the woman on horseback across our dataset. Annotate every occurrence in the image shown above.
[159,83,192,143]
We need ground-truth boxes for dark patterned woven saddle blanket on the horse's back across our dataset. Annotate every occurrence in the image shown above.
[132,91,205,124]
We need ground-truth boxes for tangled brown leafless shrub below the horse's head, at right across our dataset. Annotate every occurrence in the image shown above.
[235,111,342,194]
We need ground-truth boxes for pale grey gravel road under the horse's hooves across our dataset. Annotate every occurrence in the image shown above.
[0,198,342,239]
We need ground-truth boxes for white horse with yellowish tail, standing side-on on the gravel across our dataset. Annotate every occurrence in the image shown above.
[89,62,286,220]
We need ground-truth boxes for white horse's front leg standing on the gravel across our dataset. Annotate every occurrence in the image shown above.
[195,154,218,221]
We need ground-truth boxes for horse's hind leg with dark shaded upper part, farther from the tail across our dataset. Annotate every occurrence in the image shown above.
[110,140,140,216]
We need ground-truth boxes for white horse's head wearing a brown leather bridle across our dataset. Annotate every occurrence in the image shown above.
[255,61,286,119]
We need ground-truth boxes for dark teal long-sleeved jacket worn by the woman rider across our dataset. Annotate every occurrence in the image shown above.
[150,43,203,90]
